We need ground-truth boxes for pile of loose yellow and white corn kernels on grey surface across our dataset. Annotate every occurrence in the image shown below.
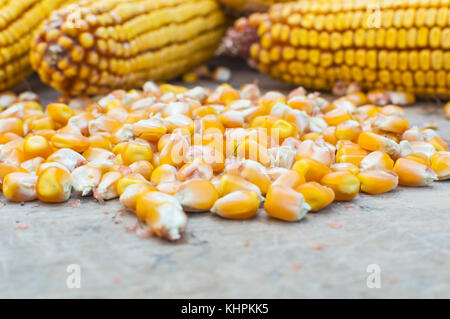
[0,82,450,240]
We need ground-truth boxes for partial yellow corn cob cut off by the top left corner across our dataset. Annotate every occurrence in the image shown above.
[0,0,73,90]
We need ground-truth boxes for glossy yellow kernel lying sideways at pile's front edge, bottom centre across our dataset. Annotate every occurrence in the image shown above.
[211,191,260,220]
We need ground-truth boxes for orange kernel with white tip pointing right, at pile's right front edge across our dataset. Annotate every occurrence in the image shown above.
[394,158,437,186]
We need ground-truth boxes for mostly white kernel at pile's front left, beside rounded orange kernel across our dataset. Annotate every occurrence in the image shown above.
[72,164,102,196]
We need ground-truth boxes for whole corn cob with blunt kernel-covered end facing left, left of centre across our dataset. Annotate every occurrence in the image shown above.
[31,0,224,95]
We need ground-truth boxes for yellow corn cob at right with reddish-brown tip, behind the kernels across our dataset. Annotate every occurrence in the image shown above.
[225,0,450,98]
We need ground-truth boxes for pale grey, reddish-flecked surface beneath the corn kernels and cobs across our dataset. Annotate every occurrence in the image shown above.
[0,61,450,298]
